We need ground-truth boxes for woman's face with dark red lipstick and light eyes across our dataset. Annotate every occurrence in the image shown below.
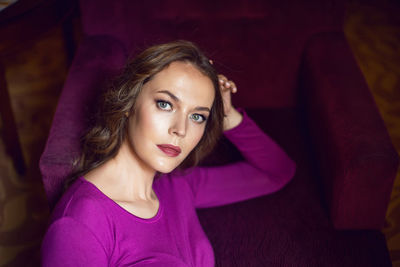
[127,62,214,173]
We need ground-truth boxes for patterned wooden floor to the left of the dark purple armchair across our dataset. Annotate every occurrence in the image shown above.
[0,24,67,266]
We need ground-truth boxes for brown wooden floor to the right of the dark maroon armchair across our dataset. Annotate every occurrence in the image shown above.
[345,2,400,267]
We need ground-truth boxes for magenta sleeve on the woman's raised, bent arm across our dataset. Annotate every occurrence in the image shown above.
[181,110,296,208]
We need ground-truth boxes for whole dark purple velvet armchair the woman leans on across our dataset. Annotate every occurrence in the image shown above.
[40,0,399,266]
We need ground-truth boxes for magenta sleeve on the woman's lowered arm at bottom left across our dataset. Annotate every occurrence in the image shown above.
[41,217,108,267]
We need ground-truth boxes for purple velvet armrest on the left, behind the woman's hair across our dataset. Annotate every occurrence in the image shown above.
[39,35,126,208]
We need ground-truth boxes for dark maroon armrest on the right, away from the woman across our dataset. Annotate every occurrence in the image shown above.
[300,32,399,229]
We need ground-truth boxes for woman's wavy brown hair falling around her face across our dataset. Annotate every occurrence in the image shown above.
[67,40,224,185]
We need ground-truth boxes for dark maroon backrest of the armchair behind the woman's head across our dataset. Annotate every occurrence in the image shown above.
[80,0,344,107]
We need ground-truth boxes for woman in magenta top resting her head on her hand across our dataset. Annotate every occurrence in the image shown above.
[42,41,295,266]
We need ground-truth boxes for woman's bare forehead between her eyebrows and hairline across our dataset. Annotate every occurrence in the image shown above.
[143,62,214,108]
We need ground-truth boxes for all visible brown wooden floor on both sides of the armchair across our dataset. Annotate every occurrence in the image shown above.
[0,0,400,267]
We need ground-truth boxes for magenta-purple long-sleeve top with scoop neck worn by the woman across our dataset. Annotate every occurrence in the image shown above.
[41,110,296,267]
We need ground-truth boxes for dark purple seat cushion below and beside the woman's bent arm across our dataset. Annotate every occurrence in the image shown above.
[198,109,391,266]
